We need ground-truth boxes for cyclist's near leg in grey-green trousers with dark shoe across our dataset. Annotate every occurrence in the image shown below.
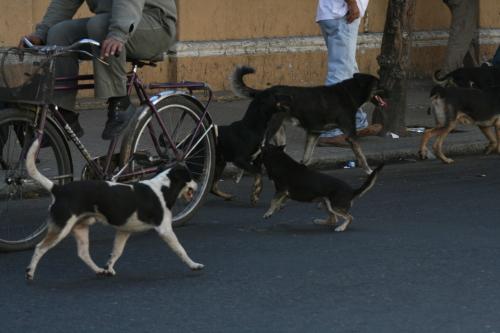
[87,10,175,140]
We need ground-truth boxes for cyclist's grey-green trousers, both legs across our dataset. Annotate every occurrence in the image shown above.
[47,9,175,110]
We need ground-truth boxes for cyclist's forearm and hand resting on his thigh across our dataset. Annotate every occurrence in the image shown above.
[107,0,146,43]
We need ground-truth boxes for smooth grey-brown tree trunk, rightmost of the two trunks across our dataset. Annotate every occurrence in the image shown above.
[439,0,479,76]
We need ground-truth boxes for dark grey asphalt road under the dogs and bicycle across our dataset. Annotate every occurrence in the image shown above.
[0,156,500,332]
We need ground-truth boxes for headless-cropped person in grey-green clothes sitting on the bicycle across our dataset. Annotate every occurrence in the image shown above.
[20,0,177,140]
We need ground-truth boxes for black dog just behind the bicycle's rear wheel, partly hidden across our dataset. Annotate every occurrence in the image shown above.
[211,67,288,205]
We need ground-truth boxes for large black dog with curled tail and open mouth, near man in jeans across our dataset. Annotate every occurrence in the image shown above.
[230,67,385,173]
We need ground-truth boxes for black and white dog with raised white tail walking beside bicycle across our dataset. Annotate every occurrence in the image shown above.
[26,140,203,280]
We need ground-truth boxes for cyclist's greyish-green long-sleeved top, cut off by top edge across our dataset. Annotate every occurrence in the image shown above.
[35,0,177,43]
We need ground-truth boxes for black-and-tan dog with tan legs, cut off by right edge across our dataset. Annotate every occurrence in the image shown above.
[419,86,500,163]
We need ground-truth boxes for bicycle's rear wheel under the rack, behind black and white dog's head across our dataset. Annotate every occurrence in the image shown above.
[121,95,215,226]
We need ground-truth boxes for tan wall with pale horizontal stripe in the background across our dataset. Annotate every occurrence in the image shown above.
[0,0,500,90]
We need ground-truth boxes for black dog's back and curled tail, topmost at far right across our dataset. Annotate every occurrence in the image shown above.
[433,66,500,89]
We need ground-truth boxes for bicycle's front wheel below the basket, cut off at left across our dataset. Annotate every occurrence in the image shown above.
[0,109,72,251]
